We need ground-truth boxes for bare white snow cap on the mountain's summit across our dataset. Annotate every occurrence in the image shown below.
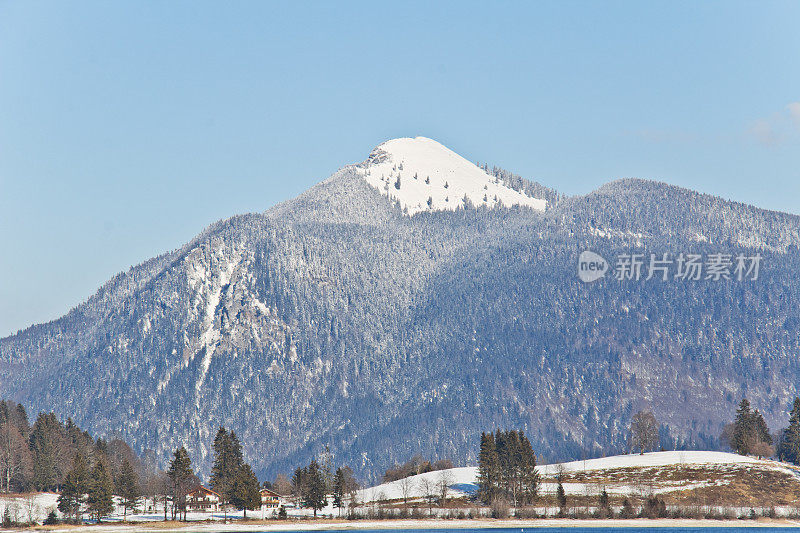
[358,137,547,215]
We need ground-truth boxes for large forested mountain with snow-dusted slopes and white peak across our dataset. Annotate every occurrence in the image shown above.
[0,138,800,476]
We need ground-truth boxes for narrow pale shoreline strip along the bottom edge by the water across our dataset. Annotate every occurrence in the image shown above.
[15,518,800,533]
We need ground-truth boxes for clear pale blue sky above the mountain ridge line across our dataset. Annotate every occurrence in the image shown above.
[0,0,800,336]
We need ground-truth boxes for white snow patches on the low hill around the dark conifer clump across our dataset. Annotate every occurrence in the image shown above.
[358,451,798,503]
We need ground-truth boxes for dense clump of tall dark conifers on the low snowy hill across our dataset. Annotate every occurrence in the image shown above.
[478,430,539,507]
